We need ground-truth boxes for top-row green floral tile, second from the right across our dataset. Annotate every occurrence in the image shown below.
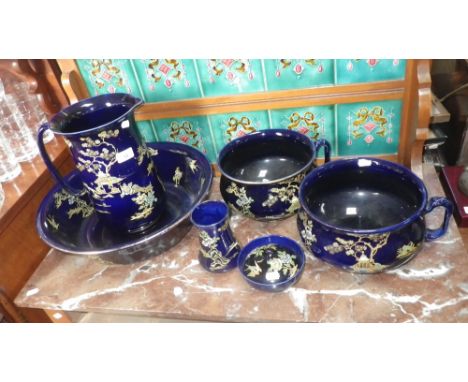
[263,59,335,90]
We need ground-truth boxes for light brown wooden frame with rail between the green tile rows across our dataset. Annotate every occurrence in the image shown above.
[58,60,431,167]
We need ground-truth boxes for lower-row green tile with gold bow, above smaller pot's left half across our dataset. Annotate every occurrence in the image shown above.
[208,111,270,152]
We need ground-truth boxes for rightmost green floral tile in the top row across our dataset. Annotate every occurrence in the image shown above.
[335,58,406,84]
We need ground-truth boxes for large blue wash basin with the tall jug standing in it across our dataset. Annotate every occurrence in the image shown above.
[36,142,213,263]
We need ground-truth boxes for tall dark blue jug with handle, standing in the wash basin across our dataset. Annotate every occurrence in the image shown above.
[38,93,165,233]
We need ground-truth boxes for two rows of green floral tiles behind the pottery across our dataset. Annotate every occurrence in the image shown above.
[76,59,406,162]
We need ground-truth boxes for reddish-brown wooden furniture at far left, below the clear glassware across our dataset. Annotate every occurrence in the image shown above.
[0,138,73,322]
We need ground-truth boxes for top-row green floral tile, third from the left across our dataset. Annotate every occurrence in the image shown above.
[196,59,265,97]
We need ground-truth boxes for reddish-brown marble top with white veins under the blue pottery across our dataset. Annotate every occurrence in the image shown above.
[15,166,468,322]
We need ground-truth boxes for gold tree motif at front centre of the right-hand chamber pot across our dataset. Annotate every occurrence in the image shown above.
[324,233,390,273]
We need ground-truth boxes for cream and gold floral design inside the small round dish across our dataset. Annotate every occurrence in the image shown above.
[245,244,298,281]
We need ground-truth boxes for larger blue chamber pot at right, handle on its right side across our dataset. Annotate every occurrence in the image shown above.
[297,158,452,273]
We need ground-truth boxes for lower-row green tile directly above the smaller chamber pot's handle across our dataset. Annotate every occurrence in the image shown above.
[270,106,336,157]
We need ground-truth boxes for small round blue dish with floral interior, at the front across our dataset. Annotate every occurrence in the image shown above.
[238,235,306,292]
